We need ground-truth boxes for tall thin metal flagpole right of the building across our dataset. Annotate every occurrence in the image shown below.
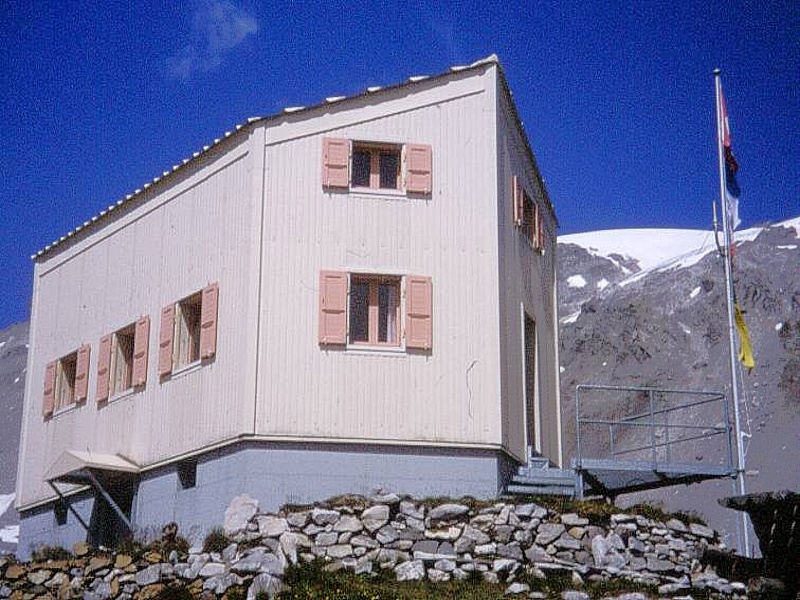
[714,69,752,557]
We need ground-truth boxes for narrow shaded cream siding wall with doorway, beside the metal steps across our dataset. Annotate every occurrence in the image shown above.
[497,89,562,464]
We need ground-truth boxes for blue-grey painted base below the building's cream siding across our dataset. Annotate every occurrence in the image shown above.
[17,442,516,560]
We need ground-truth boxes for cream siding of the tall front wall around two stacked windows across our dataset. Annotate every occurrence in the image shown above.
[257,69,501,446]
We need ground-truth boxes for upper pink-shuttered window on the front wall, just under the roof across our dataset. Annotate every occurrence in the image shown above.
[322,138,433,194]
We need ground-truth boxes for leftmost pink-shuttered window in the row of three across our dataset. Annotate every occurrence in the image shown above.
[42,344,89,418]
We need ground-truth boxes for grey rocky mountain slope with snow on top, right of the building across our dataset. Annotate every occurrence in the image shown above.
[558,219,800,545]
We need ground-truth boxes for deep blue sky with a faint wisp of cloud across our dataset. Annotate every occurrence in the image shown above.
[0,0,800,328]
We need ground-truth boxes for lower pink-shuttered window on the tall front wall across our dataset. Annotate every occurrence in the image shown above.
[319,271,433,350]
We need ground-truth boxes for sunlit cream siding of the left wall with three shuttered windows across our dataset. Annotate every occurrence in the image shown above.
[18,135,263,504]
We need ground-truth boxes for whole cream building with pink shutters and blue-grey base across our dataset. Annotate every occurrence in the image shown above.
[16,57,562,556]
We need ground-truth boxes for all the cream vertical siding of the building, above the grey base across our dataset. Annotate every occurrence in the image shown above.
[18,65,558,505]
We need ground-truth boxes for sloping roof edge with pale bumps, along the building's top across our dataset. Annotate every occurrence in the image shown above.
[31,54,504,261]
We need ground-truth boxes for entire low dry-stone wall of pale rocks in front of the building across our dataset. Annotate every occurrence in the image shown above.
[0,494,746,600]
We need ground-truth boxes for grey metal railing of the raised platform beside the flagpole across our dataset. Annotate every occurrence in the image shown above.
[575,385,733,488]
